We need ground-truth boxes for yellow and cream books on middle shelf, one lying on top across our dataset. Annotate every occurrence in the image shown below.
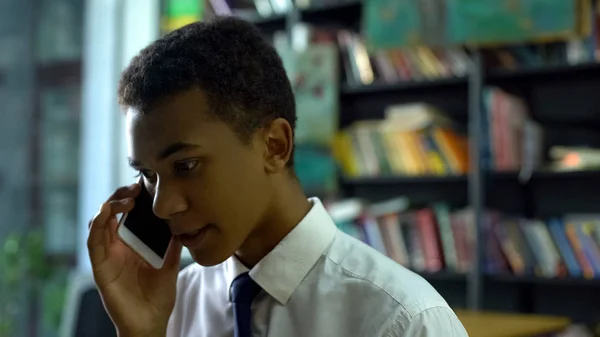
[333,103,469,177]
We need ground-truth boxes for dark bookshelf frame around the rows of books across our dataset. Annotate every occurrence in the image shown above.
[246,0,600,324]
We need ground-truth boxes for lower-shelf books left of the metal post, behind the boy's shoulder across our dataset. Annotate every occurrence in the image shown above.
[328,198,475,273]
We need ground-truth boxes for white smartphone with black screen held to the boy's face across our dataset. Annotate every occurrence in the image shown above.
[117,179,173,269]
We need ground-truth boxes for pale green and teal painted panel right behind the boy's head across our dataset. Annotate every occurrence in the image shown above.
[277,44,340,196]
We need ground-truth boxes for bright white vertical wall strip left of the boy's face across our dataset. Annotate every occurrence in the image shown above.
[78,0,160,271]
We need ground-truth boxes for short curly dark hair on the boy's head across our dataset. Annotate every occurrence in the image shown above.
[118,17,296,166]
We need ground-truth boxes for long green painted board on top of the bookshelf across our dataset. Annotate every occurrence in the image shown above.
[363,0,591,49]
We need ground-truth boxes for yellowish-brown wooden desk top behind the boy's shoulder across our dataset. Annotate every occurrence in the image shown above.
[456,310,570,337]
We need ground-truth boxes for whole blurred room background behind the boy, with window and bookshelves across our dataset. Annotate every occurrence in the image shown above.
[0,0,600,337]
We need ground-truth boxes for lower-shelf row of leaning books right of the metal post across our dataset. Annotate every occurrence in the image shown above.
[484,212,600,279]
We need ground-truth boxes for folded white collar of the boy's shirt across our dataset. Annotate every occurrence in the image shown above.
[225,198,337,305]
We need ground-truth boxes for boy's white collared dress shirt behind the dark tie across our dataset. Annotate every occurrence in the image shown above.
[167,198,467,337]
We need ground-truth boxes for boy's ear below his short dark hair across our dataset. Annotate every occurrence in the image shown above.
[264,118,294,173]
